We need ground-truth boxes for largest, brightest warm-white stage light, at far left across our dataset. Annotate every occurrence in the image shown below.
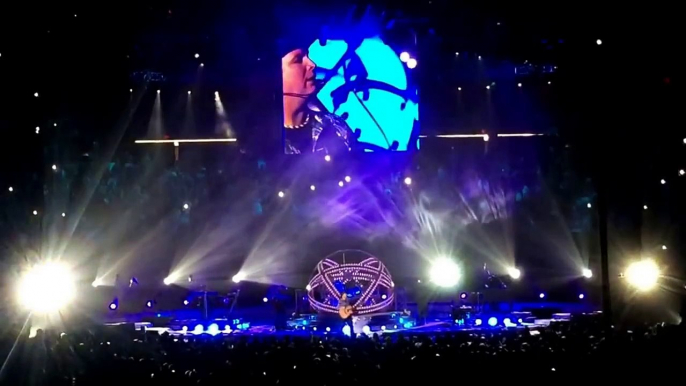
[17,262,76,313]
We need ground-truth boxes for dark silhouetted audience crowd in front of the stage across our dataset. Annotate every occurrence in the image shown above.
[2,320,685,386]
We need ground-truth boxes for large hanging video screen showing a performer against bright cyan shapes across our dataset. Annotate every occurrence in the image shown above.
[281,28,419,154]
